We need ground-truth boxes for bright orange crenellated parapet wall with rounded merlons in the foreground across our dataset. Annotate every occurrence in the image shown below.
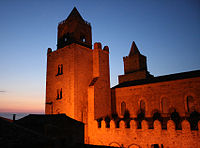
[89,120,200,148]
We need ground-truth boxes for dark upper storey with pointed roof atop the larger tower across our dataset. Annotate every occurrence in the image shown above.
[57,7,92,49]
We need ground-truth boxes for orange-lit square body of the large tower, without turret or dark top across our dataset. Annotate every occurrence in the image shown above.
[45,44,93,122]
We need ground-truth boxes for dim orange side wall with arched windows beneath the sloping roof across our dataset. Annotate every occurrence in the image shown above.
[112,77,200,118]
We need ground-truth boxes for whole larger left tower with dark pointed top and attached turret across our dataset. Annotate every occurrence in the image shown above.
[45,8,111,123]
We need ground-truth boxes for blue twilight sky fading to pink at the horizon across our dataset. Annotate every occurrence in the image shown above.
[0,0,200,113]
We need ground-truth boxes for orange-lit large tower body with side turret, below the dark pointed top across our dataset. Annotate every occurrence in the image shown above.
[45,43,111,123]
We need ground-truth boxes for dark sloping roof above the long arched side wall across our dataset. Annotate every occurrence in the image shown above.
[112,70,200,89]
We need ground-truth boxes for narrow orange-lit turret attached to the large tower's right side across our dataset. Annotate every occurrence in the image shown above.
[92,43,111,119]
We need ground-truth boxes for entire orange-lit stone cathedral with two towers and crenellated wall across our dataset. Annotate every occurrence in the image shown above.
[45,8,200,148]
